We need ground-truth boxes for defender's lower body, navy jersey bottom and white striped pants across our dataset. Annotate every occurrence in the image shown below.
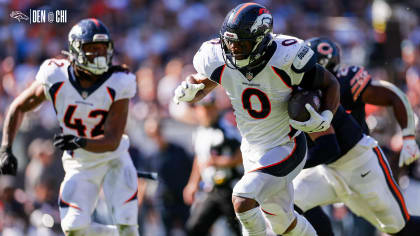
[293,106,420,236]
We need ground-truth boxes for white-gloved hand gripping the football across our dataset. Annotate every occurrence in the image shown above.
[289,103,333,133]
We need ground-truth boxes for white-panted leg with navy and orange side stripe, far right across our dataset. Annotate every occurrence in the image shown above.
[338,147,410,234]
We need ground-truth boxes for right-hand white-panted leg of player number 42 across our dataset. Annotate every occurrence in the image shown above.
[103,152,139,236]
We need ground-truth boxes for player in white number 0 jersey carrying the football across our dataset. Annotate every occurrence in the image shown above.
[174,3,339,236]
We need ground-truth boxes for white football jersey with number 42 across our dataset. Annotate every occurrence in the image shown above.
[36,59,137,168]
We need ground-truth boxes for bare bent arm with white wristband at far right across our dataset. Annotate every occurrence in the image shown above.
[361,80,420,167]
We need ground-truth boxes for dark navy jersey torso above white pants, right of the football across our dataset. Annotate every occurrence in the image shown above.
[307,106,363,164]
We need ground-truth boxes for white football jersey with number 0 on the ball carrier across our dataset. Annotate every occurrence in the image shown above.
[193,35,316,170]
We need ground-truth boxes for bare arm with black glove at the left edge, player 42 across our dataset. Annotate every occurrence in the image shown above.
[0,81,46,175]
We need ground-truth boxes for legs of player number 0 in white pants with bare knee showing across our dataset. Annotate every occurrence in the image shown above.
[232,141,316,236]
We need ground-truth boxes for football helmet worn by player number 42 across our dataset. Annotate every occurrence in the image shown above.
[63,18,114,75]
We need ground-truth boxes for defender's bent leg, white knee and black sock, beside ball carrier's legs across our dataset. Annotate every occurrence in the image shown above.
[293,166,338,236]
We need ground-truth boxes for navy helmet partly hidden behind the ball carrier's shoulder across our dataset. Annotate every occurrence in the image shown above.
[305,37,340,73]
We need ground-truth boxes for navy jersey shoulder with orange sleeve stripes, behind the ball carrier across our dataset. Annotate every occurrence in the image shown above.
[335,66,371,134]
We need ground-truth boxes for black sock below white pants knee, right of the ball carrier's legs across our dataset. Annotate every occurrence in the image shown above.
[295,205,334,236]
